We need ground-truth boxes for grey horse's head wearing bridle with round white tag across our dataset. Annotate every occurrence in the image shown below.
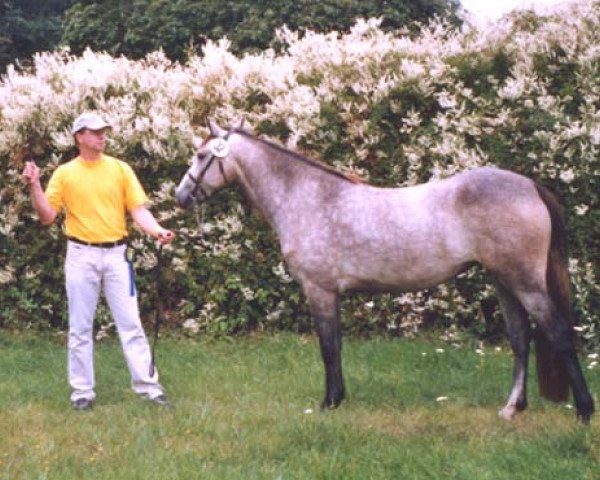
[175,120,243,208]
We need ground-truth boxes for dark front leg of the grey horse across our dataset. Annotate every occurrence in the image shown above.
[303,282,345,408]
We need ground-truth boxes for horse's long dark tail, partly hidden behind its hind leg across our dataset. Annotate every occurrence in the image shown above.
[534,184,573,402]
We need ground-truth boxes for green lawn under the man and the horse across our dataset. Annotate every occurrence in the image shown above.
[0,332,600,480]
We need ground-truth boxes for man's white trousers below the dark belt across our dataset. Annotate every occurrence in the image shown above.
[65,241,163,401]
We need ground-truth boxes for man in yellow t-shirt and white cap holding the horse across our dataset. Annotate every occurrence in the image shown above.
[23,112,175,410]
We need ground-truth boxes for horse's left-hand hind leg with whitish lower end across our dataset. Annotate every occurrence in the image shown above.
[496,282,531,420]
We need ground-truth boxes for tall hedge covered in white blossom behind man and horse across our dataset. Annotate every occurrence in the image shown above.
[0,1,600,343]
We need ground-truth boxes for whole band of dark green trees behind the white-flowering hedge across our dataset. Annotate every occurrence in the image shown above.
[0,0,459,73]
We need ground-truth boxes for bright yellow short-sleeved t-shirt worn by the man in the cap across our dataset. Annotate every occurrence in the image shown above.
[46,155,148,242]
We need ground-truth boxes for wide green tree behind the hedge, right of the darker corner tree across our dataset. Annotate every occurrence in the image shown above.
[62,0,460,61]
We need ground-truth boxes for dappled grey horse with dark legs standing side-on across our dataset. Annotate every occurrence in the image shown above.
[175,120,594,424]
